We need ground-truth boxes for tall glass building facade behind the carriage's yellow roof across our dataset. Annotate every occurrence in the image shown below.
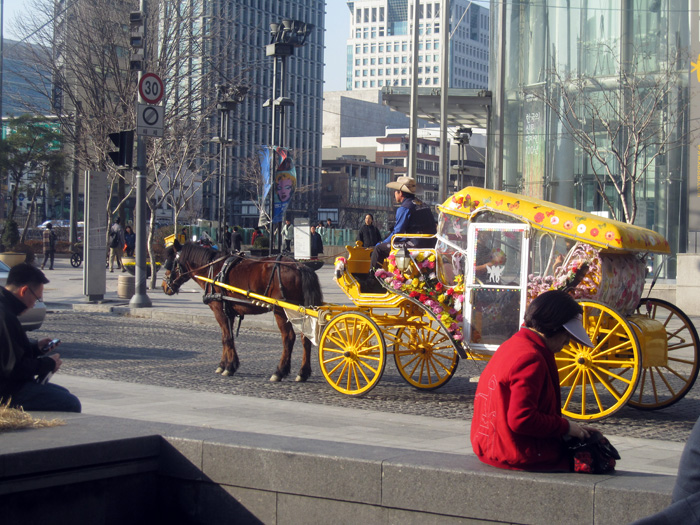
[487,0,700,277]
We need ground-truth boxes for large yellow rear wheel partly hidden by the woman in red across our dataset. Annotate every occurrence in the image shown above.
[556,301,641,420]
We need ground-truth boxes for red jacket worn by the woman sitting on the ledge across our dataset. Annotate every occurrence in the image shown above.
[471,328,569,471]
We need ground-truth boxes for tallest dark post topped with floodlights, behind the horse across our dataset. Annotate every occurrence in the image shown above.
[263,18,314,255]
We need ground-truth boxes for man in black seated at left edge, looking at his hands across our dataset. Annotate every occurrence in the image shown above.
[0,263,81,412]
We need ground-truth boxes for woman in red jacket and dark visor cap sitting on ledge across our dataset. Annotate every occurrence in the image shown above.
[471,291,595,471]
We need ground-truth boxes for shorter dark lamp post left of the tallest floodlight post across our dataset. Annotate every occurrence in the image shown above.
[212,84,248,252]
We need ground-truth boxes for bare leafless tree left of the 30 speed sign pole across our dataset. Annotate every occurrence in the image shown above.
[14,0,138,224]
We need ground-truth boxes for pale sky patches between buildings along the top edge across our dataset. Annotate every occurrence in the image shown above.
[3,0,350,91]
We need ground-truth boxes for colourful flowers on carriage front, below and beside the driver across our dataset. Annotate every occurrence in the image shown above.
[374,251,464,341]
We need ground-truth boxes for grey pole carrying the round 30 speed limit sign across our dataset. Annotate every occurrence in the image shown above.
[129,0,153,308]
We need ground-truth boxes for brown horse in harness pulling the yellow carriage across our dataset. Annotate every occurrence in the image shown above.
[163,241,323,381]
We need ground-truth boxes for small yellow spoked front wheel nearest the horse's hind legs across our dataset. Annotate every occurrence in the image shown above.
[318,312,386,396]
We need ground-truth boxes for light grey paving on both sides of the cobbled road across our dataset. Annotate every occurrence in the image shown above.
[34,259,683,478]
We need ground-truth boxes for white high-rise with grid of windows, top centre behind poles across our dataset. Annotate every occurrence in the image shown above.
[346,0,489,91]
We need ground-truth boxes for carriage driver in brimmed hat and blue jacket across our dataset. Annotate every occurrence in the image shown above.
[370,177,437,269]
